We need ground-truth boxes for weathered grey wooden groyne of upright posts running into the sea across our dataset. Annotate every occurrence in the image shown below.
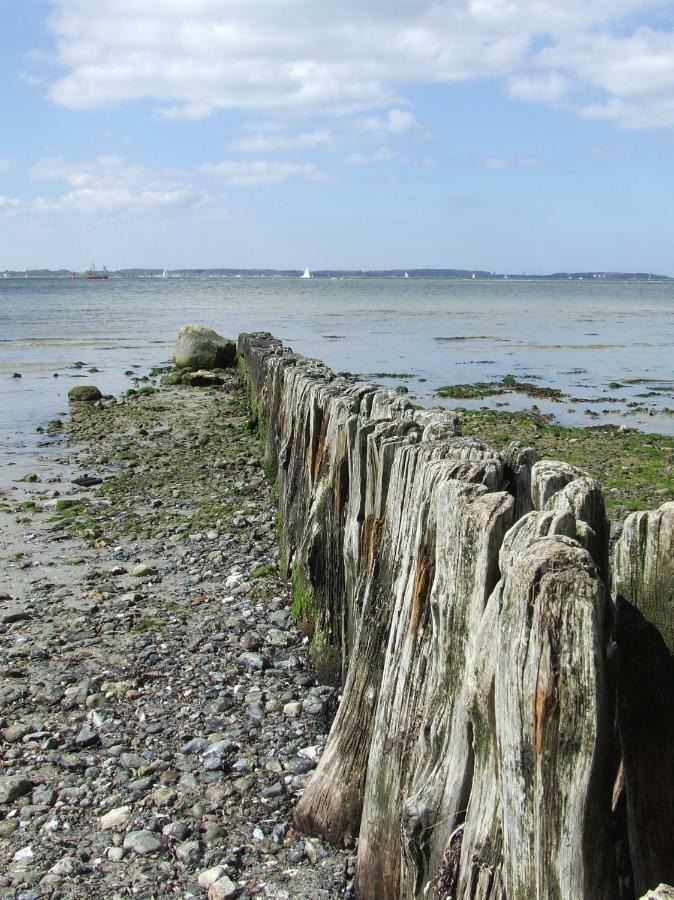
[238,334,674,900]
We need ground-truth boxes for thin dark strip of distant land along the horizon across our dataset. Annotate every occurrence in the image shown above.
[0,269,674,281]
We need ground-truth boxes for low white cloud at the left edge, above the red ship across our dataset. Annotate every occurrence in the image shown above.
[0,156,205,216]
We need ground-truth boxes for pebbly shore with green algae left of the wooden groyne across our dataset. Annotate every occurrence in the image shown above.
[0,373,352,898]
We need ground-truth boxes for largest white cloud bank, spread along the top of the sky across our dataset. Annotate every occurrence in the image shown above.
[40,0,674,128]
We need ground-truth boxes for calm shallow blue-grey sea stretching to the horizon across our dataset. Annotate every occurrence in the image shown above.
[0,276,674,480]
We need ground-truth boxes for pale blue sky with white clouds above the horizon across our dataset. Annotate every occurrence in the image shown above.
[0,0,674,275]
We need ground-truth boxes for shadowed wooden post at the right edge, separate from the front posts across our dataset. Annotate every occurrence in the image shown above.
[613,503,674,893]
